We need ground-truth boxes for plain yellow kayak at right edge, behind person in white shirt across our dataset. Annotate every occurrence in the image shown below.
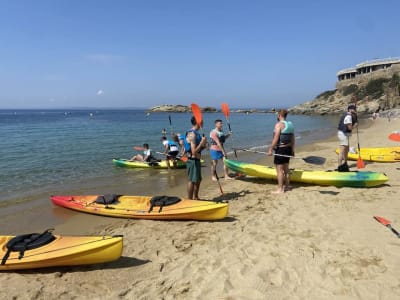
[336,147,400,162]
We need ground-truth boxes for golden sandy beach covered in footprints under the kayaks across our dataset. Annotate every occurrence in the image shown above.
[0,118,400,299]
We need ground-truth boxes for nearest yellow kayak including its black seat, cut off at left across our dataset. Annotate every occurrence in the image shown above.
[0,231,123,271]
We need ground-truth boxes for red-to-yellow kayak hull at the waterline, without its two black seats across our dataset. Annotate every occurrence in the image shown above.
[51,195,228,220]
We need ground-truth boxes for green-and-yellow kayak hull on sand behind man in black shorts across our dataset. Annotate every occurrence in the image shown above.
[225,159,388,187]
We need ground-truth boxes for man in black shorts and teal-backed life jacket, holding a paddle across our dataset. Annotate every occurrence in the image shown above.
[268,109,295,194]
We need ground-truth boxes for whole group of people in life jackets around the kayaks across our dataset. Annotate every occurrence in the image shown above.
[132,104,357,199]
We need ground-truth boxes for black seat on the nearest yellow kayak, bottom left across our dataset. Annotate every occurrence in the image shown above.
[1,229,56,265]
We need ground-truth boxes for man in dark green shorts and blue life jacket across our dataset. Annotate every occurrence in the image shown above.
[184,116,207,199]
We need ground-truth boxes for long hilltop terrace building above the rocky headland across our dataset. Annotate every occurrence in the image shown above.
[336,57,400,81]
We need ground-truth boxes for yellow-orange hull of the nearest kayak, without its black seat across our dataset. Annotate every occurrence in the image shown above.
[0,235,123,270]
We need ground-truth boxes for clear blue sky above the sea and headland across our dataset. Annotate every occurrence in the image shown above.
[0,0,400,108]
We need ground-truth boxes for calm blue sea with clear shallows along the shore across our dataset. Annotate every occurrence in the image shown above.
[0,109,337,233]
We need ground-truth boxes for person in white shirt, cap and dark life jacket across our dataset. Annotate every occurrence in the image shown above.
[337,104,357,172]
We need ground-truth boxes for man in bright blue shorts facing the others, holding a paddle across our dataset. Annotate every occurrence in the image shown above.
[210,119,233,181]
